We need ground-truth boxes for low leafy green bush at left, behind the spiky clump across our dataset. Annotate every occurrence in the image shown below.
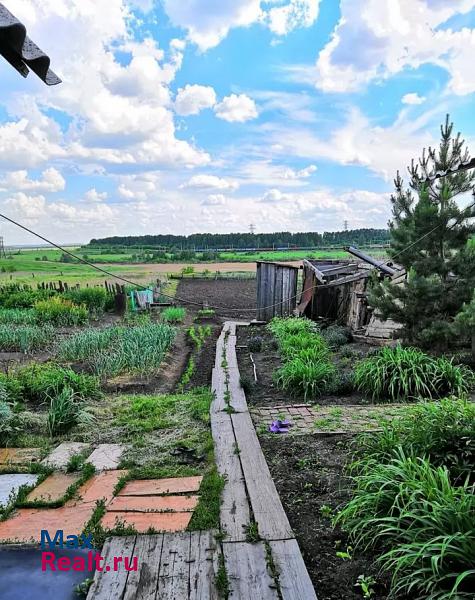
[15,363,101,404]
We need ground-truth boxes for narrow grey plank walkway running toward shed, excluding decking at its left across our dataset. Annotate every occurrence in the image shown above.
[211,321,317,600]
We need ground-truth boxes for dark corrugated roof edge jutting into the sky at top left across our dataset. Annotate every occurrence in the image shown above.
[0,2,61,85]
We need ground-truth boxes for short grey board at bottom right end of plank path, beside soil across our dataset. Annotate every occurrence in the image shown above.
[269,540,317,600]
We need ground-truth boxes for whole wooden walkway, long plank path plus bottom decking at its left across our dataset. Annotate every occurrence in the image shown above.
[87,321,317,600]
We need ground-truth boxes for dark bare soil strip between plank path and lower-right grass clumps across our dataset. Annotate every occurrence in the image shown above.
[260,434,402,600]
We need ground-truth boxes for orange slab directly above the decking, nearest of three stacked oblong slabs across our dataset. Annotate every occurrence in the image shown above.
[102,512,192,533]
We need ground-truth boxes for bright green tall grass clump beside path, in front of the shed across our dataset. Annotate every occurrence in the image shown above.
[268,318,337,399]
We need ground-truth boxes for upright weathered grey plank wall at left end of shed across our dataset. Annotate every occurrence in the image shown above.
[257,262,299,321]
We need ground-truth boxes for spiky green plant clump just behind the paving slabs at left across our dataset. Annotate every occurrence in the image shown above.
[48,386,94,437]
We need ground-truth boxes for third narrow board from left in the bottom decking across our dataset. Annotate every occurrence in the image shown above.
[155,532,190,600]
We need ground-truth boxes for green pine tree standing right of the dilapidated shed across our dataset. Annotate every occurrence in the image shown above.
[370,115,475,347]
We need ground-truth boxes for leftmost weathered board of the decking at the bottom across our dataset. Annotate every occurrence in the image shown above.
[87,536,136,600]
